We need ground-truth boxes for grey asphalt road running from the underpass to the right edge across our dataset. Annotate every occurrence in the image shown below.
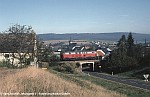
[84,71,150,91]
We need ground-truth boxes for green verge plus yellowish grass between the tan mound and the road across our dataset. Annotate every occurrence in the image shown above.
[50,70,150,97]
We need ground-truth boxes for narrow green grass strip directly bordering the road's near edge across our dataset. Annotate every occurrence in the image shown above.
[73,75,150,97]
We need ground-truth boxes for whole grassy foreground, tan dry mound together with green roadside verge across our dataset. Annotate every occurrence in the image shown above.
[0,63,150,97]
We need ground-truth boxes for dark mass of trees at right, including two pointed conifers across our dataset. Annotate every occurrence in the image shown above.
[105,33,150,73]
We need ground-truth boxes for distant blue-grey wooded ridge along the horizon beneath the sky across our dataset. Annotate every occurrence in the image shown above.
[38,32,150,42]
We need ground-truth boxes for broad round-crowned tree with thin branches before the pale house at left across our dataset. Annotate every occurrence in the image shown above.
[1,24,35,65]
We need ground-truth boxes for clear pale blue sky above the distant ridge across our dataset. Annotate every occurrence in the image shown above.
[0,0,150,34]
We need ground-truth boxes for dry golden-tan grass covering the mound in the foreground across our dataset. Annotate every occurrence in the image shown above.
[0,67,123,97]
